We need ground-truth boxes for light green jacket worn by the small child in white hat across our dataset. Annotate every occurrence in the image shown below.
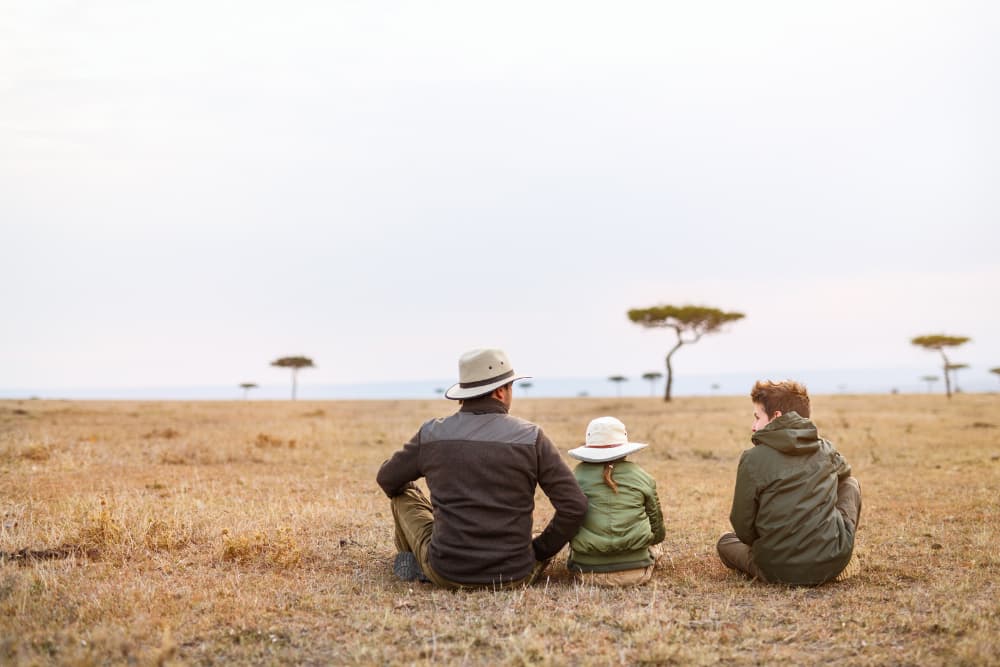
[567,460,666,572]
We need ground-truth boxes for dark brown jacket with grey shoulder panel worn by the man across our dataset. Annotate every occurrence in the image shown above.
[377,397,587,584]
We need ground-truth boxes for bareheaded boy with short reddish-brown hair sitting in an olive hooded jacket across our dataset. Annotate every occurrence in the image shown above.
[718,380,861,586]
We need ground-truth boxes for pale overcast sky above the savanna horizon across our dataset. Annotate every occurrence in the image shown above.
[0,0,1000,389]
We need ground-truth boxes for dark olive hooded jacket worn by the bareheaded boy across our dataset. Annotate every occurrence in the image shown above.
[729,412,854,585]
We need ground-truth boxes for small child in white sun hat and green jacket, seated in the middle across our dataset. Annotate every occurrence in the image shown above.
[566,417,666,586]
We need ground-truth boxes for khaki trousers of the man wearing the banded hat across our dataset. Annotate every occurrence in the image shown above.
[391,486,548,588]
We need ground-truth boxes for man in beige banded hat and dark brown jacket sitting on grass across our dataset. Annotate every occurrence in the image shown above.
[377,349,587,588]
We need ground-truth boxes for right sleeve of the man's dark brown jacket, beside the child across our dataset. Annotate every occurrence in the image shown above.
[531,430,587,561]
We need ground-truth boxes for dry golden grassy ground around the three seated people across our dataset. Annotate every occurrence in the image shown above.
[0,395,1000,665]
